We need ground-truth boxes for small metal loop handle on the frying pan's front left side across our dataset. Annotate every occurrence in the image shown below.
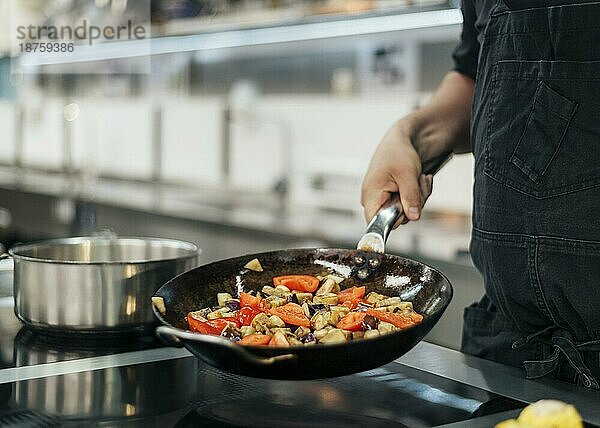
[156,325,296,367]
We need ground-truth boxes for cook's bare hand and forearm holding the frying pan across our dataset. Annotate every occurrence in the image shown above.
[361,71,475,228]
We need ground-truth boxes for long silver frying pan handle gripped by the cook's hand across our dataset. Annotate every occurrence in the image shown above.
[357,152,452,253]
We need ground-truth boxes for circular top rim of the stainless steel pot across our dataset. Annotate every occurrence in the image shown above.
[8,236,202,266]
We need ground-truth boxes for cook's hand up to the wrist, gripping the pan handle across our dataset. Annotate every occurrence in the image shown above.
[361,121,433,228]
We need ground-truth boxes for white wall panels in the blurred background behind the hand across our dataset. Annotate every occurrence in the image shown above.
[0,95,472,213]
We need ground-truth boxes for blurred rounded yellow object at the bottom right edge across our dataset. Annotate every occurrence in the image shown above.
[496,400,583,428]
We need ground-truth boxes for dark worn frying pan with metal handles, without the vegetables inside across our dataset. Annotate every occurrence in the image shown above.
[154,152,452,380]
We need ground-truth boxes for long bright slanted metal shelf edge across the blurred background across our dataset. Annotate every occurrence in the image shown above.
[17,9,462,68]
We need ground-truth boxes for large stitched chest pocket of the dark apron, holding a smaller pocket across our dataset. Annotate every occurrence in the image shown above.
[484,60,600,199]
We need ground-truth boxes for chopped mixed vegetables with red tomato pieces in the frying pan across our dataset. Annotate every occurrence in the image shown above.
[183,266,423,347]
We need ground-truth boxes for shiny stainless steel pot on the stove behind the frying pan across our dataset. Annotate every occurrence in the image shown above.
[9,236,199,333]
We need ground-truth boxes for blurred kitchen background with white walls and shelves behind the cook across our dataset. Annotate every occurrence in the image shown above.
[0,0,482,347]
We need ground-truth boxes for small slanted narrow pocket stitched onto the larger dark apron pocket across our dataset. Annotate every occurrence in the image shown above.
[510,82,577,183]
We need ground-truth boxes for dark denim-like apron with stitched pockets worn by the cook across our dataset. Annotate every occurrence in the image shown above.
[462,1,600,388]
